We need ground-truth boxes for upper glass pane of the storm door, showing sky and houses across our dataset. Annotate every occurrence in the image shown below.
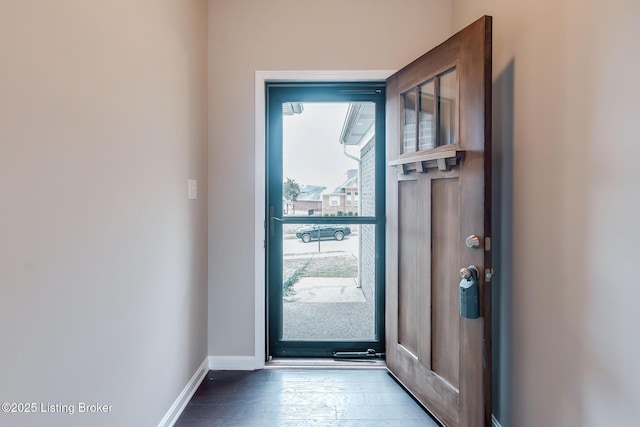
[282,102,376,216]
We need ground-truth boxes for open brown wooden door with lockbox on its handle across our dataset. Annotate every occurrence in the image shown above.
[386,16,492,427]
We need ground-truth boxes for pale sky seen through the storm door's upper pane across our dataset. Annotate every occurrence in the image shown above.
[283,102,358,190]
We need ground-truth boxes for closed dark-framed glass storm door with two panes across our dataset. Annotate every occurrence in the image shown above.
[265,82,385,357]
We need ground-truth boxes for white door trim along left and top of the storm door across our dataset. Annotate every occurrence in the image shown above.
[251,70,396,370]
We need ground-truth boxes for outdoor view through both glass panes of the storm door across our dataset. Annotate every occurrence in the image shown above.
[282,103,375,341]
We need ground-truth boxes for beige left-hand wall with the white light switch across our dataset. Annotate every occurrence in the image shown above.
[0,0,207,427]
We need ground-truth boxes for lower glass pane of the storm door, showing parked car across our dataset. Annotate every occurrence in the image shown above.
[281,224,377,341]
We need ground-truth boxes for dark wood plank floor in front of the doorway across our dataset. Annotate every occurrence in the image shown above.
[176,369,438,427]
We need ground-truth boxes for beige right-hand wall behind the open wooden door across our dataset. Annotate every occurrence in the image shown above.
[453,0,640,427]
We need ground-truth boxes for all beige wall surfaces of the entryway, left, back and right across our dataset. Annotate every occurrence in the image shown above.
[0,0,640,427]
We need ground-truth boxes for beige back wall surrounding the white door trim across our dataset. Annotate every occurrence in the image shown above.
[208,0,451,357]
